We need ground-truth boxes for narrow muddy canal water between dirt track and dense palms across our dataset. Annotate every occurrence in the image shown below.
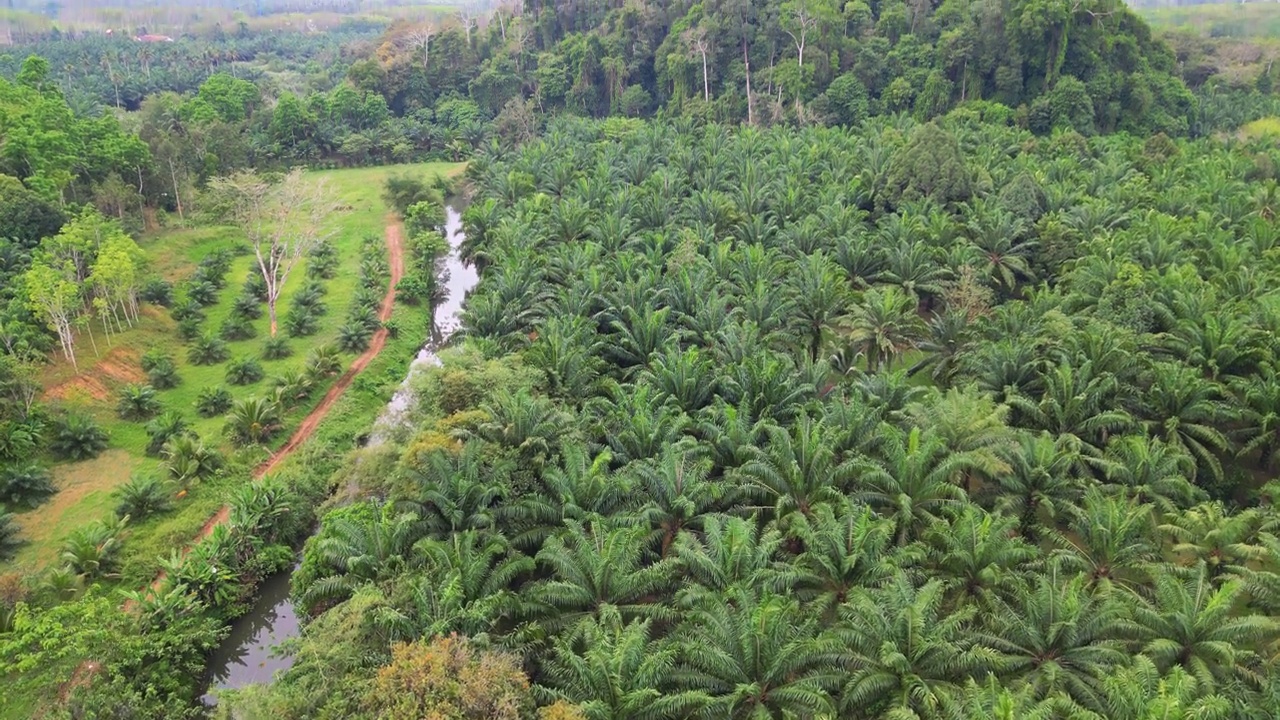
[201,205,479,705]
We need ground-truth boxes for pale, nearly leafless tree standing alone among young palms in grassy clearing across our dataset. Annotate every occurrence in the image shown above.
[210,170,337,337]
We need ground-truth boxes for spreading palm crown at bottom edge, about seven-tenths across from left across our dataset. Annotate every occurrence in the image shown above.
[836,571,1001,719]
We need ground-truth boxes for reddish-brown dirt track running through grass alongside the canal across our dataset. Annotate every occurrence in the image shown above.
[125,223,404,599]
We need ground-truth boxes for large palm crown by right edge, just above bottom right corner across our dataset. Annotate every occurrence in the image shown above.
[1134,565,1280,692]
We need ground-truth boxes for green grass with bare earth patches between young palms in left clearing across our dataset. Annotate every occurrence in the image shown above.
[0,163,462,583]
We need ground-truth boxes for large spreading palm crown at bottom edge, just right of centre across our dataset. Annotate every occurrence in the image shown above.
[676,588,847,720]
